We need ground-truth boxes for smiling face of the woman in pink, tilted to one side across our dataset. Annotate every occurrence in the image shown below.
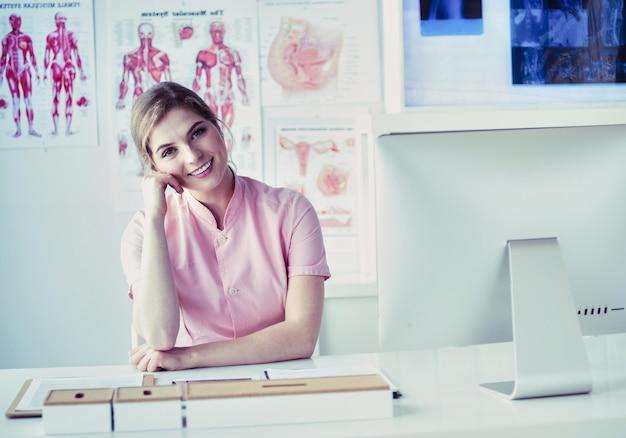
[150,108,230,198]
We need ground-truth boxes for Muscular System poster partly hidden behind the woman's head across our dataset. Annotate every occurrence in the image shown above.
[103,0,263,211]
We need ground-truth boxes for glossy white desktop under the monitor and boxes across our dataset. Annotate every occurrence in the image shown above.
[0,335,626,438]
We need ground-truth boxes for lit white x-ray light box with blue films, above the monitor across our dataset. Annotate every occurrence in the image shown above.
[398,0,626,108]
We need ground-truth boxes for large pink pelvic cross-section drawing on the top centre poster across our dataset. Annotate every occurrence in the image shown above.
[267,17,343,91]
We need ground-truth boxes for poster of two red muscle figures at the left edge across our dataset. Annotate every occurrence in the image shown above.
[0,0,98,149]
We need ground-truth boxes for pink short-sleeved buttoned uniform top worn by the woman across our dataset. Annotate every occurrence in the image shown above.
[121,176,330,346]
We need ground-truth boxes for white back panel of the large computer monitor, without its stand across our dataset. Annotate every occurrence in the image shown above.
[374,125,626,350]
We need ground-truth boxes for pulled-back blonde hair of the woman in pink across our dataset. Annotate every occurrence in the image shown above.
[130,82,224,171]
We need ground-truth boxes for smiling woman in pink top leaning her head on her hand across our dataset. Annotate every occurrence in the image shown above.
[121,82,330,371]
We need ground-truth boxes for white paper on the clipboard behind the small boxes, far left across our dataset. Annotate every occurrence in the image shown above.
[15,374,144,411]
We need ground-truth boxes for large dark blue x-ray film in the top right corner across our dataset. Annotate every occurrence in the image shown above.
[511,0,626,84]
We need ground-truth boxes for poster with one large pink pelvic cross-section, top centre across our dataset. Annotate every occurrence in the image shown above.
[258,0,381,106]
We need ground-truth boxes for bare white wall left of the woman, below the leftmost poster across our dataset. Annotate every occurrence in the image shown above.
[0,147,130,368]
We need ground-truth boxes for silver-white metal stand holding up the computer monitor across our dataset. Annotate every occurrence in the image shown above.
[481,238,592,400]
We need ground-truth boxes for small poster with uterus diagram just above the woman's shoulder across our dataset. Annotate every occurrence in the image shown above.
[276,127,360,235]
